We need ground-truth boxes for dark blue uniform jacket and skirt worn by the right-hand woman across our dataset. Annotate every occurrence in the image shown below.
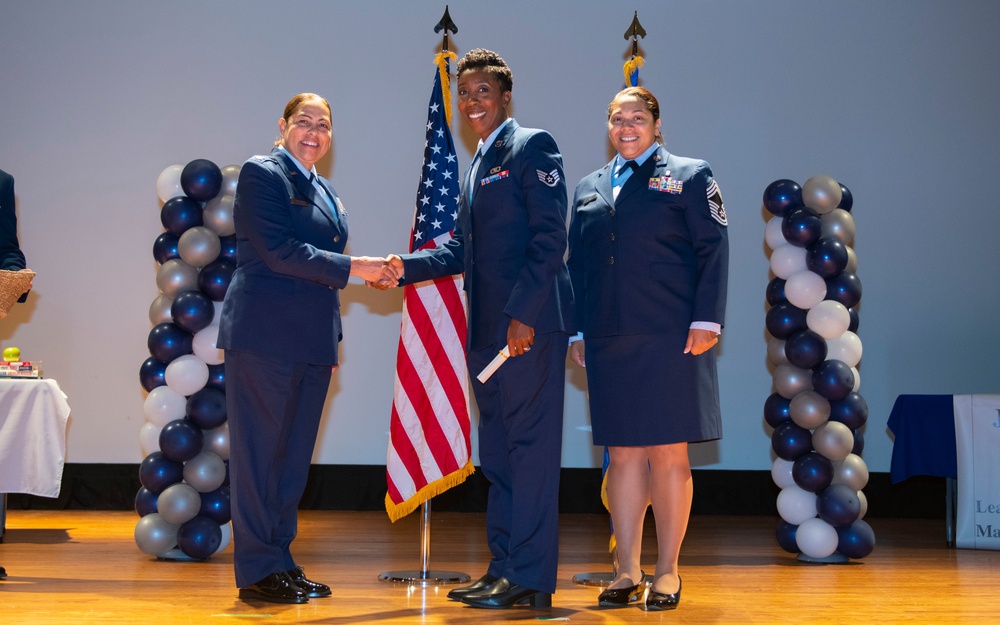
[568,146,729,446]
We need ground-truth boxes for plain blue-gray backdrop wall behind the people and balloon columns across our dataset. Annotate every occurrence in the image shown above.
[0,0,1000,471]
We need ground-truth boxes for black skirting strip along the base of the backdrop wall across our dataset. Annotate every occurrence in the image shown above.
[7,464,945,519]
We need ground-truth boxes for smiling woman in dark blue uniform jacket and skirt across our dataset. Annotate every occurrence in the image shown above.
[568,87,729,610]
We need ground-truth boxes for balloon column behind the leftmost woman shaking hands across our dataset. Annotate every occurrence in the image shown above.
[135,159,240,560]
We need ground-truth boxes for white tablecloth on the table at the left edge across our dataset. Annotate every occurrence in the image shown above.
[0,380,69,497]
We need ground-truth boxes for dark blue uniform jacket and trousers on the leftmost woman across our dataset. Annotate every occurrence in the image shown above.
[217,148,351,588]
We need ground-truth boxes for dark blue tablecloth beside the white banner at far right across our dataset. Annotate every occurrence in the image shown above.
[888,395,958,484]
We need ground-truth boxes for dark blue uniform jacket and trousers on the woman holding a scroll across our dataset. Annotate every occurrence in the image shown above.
[403,119,574,593]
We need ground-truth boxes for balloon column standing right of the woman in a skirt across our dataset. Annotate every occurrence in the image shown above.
[764,176,875,562]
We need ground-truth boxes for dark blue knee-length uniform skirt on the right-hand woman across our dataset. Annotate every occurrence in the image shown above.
[584,331,722,447]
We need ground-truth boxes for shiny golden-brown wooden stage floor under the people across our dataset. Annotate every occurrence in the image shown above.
[0,510,1000,625]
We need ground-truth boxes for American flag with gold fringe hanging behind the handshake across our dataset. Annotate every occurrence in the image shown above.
[385,58,473,521]
